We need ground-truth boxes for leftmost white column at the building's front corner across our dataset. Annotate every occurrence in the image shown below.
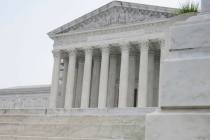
[49,51,61,109]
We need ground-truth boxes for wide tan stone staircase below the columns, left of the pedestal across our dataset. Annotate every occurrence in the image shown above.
[0,108,155,140]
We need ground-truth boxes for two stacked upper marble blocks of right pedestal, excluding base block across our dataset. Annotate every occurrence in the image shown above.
[160,14,210,107]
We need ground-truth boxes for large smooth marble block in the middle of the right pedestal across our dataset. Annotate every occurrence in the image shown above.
[160,56,210,107]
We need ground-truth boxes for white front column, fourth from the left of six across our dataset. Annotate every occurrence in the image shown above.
[98,48,109,108]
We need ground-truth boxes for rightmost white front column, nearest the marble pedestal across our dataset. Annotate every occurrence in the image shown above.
[138,42,149,107]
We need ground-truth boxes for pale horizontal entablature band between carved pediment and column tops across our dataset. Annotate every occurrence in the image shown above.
[50,13,192,50]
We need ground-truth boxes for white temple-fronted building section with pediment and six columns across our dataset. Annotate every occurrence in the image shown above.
[48,1,175,109]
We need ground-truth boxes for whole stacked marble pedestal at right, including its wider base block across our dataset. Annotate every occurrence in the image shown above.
[146,11,210,140]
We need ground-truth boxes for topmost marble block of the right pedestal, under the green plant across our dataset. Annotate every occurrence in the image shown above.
[170,14,210,50]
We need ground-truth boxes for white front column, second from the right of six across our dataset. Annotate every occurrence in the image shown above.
[118,46,129,108]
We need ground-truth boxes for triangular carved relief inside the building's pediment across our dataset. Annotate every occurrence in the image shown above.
[58,7,173,34]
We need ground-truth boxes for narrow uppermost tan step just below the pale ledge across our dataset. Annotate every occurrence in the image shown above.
[0,115,145,125]
